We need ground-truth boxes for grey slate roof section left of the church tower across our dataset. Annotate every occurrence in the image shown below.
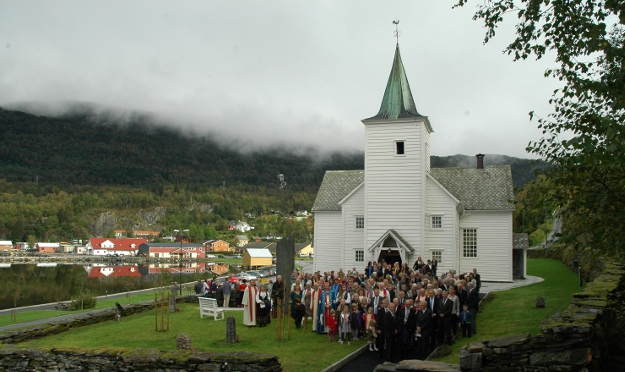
[312,170,365,212]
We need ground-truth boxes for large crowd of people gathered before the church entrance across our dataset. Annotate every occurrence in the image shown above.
[229,257,481,361]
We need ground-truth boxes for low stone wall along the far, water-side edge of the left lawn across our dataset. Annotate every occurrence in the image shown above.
[0,295,198,344]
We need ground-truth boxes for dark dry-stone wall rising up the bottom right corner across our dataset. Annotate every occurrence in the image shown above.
[460,261,625,372]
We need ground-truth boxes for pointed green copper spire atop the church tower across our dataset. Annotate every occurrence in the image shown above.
[367,45,422,120]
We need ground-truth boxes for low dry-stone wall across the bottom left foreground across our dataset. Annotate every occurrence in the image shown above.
[0,345,282,372]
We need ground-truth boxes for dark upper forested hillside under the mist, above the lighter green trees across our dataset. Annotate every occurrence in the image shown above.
[0,108,542,192]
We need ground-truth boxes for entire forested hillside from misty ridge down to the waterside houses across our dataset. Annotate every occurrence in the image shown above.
[0,108,545,243]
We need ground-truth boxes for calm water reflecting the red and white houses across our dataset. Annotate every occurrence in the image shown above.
[0,262,238,309]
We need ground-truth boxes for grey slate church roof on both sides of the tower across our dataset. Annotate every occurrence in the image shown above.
[312,165,514,212]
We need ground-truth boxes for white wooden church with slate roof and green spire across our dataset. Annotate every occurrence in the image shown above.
[312,46,527,282]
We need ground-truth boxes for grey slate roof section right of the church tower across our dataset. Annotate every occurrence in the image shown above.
[430,165,514,210]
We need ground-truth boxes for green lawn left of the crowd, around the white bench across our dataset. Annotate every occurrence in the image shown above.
[21,304,358,372]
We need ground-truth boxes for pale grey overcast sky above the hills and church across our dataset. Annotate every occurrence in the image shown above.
[0,0,557,157]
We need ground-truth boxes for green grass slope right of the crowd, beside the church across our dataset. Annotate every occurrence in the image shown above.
[432,258,583,364]
